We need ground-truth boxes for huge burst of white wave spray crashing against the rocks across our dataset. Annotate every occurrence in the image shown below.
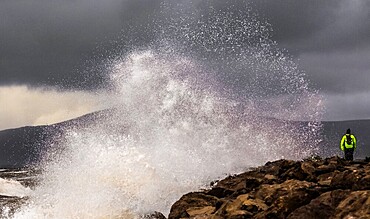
[10,4,321,218]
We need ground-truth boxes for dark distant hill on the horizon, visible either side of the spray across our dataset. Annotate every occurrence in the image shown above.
[0,110,370,168]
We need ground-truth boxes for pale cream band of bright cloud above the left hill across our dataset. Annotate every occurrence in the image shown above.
[0,86,103,130]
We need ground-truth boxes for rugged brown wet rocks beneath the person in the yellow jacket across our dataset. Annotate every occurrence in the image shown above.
[168,157,370,219]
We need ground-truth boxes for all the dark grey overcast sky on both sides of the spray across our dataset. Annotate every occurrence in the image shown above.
[0,0,370,120]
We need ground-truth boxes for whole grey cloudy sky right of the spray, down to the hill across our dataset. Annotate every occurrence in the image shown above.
[254,0,370,120]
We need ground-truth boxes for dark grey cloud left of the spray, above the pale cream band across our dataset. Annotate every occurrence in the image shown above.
[0,0,160,89]
